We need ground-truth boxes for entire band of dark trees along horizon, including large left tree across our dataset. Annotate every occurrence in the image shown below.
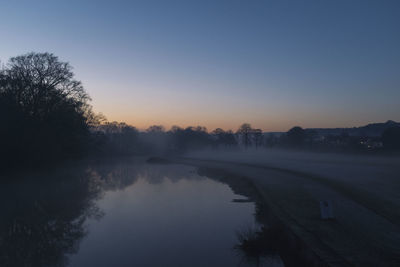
[0,53,400,170]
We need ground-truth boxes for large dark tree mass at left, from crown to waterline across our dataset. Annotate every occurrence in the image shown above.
[0,53,98,164]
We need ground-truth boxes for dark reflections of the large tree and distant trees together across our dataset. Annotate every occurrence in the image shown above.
[0,160,200,267]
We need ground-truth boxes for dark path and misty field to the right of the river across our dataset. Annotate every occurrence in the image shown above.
[170,152,400,266]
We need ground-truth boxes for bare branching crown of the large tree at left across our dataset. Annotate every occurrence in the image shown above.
[0,53,91,119]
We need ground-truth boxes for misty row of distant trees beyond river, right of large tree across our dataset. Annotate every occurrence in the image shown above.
[92,122,262,155]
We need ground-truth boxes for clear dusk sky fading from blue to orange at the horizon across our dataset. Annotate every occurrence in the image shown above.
[0,0,400,131]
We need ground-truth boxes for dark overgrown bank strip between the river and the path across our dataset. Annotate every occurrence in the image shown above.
[198,167,328,267]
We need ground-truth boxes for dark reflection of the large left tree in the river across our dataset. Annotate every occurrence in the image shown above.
[0,165,101,266]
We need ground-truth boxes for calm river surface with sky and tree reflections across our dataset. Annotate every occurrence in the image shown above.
[0,160,282,267]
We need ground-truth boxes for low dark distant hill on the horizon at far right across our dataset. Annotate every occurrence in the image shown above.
[306,120,400,137]
